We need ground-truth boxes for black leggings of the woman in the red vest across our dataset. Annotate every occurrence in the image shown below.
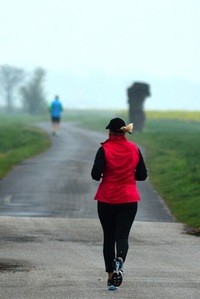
[98,201,137,273]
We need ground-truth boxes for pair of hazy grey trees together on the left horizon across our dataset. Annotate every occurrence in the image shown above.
[0,64,47,114]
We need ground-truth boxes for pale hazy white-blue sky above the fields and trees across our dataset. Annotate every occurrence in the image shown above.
[0,0,200,110]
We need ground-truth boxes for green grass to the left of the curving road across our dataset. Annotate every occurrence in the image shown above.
[0,115,50,178]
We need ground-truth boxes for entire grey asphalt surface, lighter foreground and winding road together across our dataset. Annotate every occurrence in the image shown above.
[0,123,200,299]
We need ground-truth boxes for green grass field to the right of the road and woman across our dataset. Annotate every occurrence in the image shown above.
[133,118,200,227]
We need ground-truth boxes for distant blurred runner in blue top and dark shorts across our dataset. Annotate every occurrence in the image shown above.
[49,95,63,136]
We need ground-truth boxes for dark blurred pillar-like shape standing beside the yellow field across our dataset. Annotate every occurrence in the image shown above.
[127,82,150,131]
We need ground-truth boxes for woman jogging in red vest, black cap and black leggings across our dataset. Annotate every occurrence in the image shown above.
[91,118,147,290]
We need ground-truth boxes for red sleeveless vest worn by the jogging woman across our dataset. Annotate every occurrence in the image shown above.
[95,136,140,204]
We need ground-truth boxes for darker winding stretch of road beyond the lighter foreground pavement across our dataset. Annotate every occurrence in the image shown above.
[0,123,173,222]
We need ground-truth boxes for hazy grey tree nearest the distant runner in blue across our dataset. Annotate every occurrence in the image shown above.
[20,68,47,114]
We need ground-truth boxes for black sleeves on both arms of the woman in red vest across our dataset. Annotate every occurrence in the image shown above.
[91,146,147,181]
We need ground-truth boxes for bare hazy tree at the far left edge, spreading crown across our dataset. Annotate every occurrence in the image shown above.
[0,64,24,112]
